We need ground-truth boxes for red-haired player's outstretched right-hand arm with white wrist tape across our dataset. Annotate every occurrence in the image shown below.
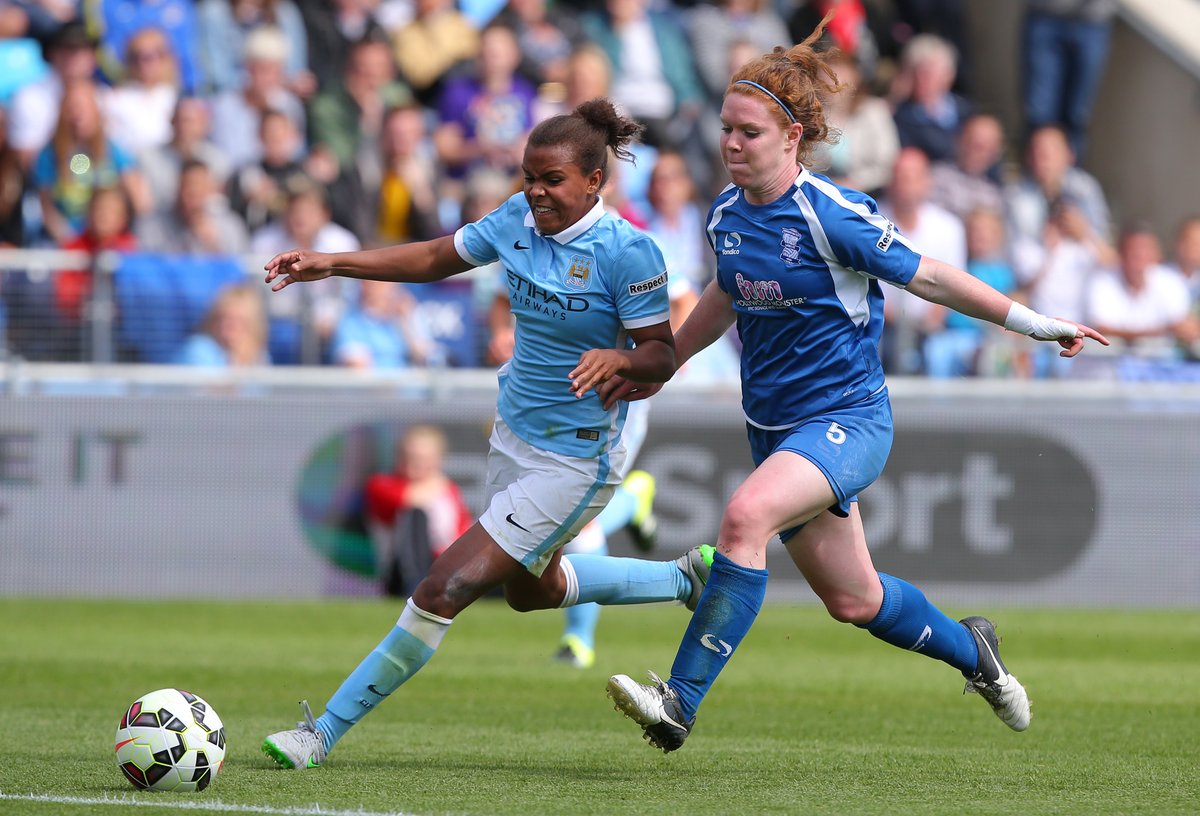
[905,256,1109,356]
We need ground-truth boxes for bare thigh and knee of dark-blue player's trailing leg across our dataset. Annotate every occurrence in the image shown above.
[786,502,883,623]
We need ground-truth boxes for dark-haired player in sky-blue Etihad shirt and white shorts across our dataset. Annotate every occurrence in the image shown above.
[263,100,701,768]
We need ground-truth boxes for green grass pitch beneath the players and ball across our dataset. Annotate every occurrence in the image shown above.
[0,600,1200,816]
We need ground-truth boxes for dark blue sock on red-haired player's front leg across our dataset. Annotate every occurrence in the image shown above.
[668,553,767,720]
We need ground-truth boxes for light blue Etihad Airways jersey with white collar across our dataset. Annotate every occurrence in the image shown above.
[455,193,671,457]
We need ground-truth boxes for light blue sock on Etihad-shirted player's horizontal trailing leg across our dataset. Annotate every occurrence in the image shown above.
[562,553,691,606]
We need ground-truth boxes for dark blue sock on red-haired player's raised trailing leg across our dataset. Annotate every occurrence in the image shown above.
[859,572,979,673]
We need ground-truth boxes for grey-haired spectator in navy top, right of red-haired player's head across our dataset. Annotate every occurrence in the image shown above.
[894,34,971,162]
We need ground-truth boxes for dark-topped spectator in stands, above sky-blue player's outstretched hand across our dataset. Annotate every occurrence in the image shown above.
[228,110,311,233]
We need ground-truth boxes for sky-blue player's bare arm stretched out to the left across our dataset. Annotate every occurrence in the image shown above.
[263,235,472,292]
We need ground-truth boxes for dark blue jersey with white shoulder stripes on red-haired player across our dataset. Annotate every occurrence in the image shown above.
[708,168,920,430]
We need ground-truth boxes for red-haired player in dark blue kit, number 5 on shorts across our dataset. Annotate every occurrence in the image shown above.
[602,24,1108,751]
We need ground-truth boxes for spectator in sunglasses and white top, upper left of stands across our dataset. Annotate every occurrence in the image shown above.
[104,29,179,155]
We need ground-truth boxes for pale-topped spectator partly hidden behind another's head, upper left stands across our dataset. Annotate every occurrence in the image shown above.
[138,96,230,212]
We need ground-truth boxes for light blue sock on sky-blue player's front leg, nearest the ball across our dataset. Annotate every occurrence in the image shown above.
[317,598,451,751]
